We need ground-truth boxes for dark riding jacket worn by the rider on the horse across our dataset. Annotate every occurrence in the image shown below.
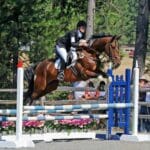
[56,30,85,52]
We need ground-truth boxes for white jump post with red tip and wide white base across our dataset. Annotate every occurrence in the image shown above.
[0,60,35,148]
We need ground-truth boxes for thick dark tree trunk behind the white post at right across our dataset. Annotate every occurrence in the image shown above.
[133,0,150,76]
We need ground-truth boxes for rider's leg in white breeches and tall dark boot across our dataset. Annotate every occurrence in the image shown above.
[56,46,67,81]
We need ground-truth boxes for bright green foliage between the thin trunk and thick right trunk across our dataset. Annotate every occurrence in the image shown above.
[95,0,138,44]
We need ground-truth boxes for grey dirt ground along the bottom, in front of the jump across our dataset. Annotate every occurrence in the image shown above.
[0,140,150,150]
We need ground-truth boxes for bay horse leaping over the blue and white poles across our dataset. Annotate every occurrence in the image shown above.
[25,36,121,105]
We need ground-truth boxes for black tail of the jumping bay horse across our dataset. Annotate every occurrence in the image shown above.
[24,64,37,103]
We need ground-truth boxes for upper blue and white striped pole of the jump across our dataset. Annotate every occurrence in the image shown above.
[0,103,133,115]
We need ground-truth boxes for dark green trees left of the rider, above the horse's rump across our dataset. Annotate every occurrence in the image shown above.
[0,0,87,87]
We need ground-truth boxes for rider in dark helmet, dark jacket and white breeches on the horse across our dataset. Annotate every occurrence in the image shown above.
[56,20,88,81]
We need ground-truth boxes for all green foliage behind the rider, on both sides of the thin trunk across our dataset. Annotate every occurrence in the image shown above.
[0,0,141,87]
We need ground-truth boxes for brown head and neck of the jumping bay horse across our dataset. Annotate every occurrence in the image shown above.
[91,36,121,67]
